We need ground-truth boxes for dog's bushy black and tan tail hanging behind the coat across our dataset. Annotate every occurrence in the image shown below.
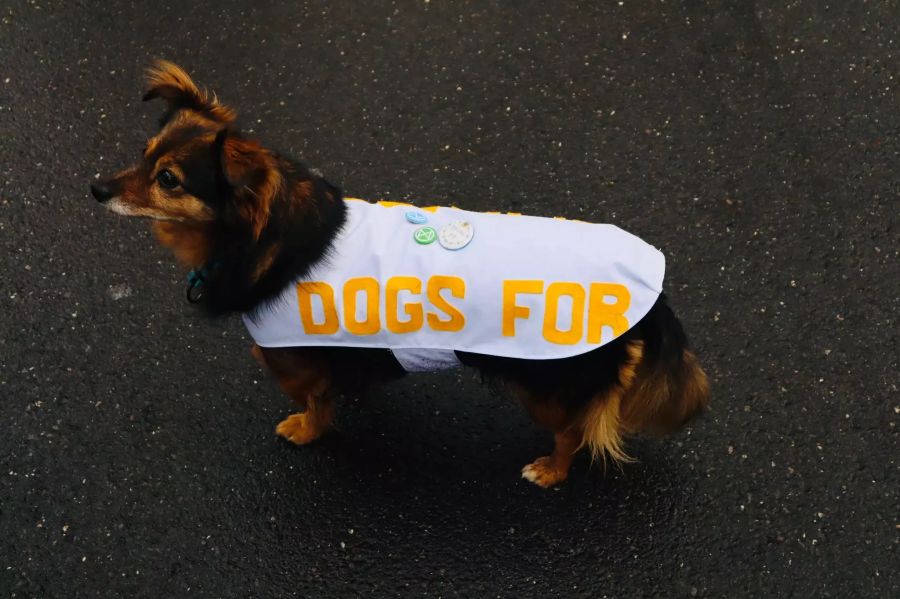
[582,296,709,462]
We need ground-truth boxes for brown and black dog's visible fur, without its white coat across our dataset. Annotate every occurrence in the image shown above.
[91,61,709,487]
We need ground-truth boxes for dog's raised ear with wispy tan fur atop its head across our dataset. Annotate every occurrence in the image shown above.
[143,60,237,125]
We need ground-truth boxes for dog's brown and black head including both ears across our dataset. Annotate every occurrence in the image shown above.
[91,60,281,237]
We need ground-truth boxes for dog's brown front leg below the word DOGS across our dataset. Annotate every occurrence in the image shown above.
[251,345,334,445]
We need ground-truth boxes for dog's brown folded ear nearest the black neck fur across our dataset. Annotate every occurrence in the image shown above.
[213,129,281,240]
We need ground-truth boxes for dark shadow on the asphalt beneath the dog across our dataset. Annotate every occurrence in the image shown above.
[268,377,696,546]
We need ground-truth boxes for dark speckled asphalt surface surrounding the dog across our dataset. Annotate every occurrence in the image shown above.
[0,0,900,598]
